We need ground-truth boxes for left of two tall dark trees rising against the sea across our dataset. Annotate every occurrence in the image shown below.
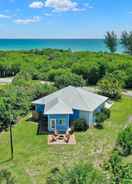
[105,31,117,53]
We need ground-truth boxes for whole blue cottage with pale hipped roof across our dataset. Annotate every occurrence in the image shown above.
[32,86,108,132]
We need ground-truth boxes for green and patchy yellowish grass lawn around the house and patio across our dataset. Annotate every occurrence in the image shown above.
[0,97,132,184]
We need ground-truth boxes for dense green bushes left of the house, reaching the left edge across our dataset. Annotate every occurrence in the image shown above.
[0,72,56,129]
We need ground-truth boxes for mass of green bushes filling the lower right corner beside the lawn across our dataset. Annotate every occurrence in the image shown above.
[105,125,132,184]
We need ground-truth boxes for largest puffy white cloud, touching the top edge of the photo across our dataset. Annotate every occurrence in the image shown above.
[45,0,81,11]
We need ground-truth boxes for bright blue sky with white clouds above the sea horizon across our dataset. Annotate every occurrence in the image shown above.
[0,0,132,38]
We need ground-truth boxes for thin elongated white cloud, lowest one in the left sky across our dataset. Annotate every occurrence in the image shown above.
[15,16,40,25]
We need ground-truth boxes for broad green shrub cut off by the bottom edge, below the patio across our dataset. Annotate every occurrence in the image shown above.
[47,163,108,184]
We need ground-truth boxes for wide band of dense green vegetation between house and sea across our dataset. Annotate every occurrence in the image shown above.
[0,49,132,88]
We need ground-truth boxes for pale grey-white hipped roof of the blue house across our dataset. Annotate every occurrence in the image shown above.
[33,86,108,114]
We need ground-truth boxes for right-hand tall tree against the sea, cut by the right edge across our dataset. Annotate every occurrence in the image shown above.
[121,31,132,55]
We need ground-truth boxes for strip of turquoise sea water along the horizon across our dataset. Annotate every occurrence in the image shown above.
[0,39,122,52]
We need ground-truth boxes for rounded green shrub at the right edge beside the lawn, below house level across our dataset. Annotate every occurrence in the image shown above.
[117,125,132,156]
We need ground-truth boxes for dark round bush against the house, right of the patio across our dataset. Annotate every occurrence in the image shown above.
[73,119,88,132]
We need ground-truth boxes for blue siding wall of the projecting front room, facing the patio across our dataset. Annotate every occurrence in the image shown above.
[48,114,69,132]
